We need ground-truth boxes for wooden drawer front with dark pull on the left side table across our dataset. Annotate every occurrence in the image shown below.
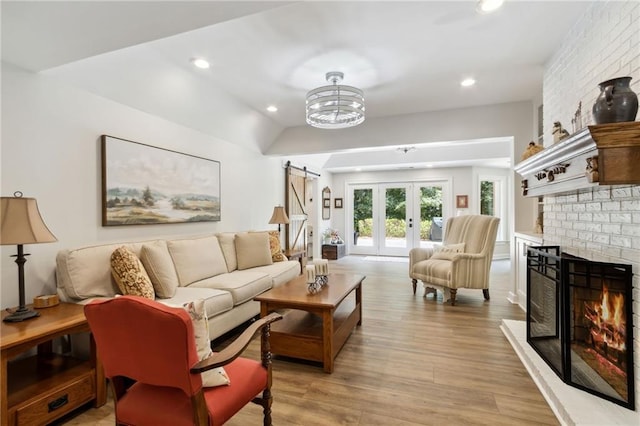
[16,373,95,426]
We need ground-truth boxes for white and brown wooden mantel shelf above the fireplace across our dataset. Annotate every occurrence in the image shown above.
[514,121,640,197]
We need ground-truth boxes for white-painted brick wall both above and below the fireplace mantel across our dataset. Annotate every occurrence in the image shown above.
[543,1,640,410]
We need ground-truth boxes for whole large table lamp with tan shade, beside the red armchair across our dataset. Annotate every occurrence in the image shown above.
[0,191,58,322]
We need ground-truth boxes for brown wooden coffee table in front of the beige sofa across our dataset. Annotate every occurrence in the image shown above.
[255,274,365,373]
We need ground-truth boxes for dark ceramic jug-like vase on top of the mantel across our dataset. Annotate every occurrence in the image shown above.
[593,77,638,124]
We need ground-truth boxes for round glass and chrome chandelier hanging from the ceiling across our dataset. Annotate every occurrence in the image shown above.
[307,71,364,129]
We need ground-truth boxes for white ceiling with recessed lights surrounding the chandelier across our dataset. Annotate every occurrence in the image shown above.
[2,0,589,171]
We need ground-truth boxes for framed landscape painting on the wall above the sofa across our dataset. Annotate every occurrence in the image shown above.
[102,135,220,226]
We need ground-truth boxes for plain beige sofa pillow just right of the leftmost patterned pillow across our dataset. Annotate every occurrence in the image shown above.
[140,241,179,299]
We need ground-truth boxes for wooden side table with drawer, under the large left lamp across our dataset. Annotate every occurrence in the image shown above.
[0,303,107,426]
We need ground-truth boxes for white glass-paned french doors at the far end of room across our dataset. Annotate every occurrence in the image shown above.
[347,181,451,256]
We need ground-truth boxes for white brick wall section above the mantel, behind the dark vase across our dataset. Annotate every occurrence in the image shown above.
[542,1,640,146]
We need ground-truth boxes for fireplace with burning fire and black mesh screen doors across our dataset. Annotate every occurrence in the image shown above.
[527,246,635,410]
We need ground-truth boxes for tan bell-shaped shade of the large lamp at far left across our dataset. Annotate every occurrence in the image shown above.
[0,193,58,246]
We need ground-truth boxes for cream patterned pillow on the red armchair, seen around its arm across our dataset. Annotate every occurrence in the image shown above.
[183,299,231,387]
